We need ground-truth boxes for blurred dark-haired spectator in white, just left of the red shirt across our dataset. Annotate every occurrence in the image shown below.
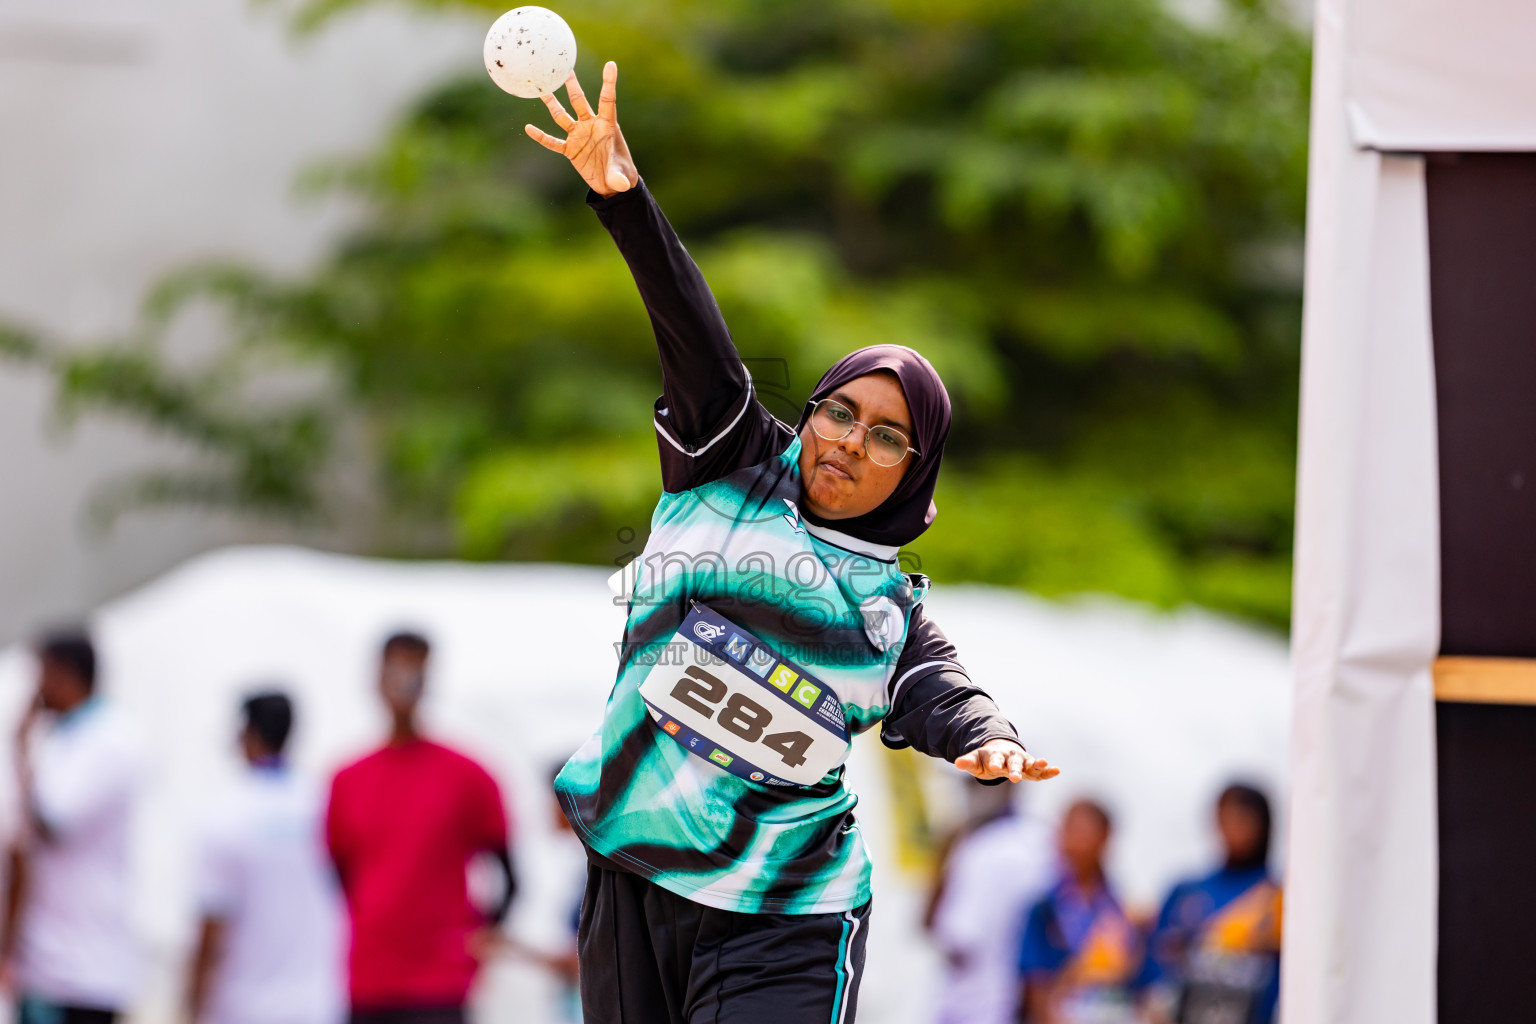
[189,692,341,1024]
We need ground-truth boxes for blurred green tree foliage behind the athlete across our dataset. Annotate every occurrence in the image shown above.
[6,0,1309,623]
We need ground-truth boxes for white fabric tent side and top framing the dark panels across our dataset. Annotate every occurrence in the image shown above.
[1281,0,1536,1024]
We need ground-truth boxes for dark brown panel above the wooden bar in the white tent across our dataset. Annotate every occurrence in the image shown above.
[1427,154,1536,660]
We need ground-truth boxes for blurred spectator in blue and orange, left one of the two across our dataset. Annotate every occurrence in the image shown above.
[1018,800,1141,1024]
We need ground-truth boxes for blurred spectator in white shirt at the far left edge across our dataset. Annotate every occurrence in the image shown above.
[0,633,141,1024]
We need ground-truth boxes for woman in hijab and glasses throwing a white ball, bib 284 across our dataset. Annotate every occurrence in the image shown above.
[527,61,1057,1024]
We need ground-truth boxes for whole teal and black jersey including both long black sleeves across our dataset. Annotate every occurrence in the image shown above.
[556,186,1015,913]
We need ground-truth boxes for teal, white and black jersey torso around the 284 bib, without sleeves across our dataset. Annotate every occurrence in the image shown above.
[556,439,917,913]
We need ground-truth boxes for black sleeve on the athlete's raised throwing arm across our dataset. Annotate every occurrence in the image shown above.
[587,181,791,491]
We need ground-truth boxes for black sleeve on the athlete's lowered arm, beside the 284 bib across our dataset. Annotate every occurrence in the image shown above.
[880,605,1018,767]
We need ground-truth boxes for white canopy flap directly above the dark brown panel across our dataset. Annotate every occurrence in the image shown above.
[1339,0,1536,152]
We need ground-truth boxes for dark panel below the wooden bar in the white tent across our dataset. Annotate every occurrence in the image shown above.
[1435,703,1536,1024]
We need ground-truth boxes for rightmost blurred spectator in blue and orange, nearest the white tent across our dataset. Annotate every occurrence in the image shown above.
[1141,785,1281,1024]
